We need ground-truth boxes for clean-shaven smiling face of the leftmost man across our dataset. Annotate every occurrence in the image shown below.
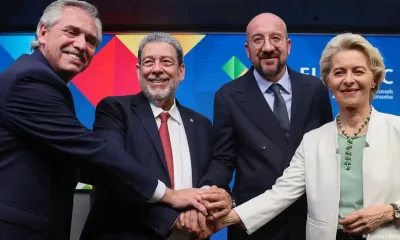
[38,7,98,81]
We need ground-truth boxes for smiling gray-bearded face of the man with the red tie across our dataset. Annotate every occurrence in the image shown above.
[136,42,185,101]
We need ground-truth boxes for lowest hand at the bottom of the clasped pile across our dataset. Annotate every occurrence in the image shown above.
[177,209,214,239]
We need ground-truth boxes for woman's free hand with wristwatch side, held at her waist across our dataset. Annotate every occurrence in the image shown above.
[339,204,394,235]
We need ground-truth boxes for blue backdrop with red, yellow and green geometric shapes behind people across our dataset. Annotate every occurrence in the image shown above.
[0,33,400,239]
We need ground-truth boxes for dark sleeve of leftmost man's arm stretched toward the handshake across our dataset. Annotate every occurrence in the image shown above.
[1,78,158,203]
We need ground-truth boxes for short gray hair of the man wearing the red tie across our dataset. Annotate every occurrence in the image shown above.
[138,32,183,66]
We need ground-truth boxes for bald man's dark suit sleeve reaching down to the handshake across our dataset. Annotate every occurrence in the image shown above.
[199,90,237,189]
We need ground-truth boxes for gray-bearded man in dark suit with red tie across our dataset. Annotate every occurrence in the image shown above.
[81,33,212,240]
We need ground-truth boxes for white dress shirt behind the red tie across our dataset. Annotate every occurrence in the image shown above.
[150,101,193,240]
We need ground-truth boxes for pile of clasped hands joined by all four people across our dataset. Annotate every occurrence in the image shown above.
[161,186,240,239]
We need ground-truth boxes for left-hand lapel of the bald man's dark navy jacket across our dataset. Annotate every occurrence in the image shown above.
[232,68,288,151]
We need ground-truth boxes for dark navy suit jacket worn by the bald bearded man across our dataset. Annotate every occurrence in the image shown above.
[201,68,333,240]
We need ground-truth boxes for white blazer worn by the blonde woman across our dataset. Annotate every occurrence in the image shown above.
[236,109,400,240]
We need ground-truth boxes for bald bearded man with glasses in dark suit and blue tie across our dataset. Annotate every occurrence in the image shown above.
[200,13,333,240]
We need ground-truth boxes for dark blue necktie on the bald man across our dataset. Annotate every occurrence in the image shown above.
[269,83,290,136]
